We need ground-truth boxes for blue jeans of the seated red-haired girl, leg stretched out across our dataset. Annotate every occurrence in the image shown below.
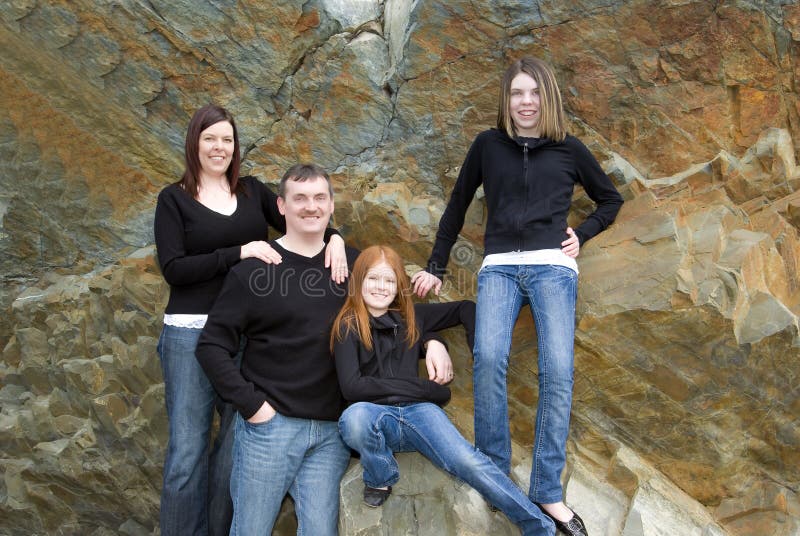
[339,402,555,536]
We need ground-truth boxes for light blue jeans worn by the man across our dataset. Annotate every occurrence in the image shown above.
[231,413,350,536]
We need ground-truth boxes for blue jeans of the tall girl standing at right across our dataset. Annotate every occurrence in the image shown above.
[473,265,578,504]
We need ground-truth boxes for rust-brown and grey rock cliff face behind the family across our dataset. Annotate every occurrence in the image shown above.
[0,0,800,536]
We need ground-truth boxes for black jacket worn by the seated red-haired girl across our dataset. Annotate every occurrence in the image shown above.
[333,300,475,405]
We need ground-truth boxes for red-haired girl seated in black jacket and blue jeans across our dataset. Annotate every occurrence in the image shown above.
[331,246,555,536]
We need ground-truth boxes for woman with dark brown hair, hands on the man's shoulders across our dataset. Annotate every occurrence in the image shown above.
[154,104,347,536]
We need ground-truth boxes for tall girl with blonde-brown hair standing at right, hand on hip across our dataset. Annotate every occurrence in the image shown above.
[412,58,622,535]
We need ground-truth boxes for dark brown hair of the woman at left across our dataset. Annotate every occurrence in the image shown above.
[178,104,242,197]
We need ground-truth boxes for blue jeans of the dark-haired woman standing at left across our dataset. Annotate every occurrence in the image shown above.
[158,325,234,536]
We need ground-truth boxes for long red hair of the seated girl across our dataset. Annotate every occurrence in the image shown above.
[330,246,419,352]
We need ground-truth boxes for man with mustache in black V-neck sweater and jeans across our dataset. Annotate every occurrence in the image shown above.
[196,164,452,536]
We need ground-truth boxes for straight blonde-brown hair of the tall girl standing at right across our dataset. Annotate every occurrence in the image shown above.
[497,57,567,141]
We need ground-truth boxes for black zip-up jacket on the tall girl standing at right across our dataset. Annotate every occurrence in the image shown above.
[427,129,622,278]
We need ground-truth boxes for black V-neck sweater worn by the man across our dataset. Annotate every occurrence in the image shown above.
[196,242,358,421]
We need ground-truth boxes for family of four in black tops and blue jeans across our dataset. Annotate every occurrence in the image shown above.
[154,58,622,536]
